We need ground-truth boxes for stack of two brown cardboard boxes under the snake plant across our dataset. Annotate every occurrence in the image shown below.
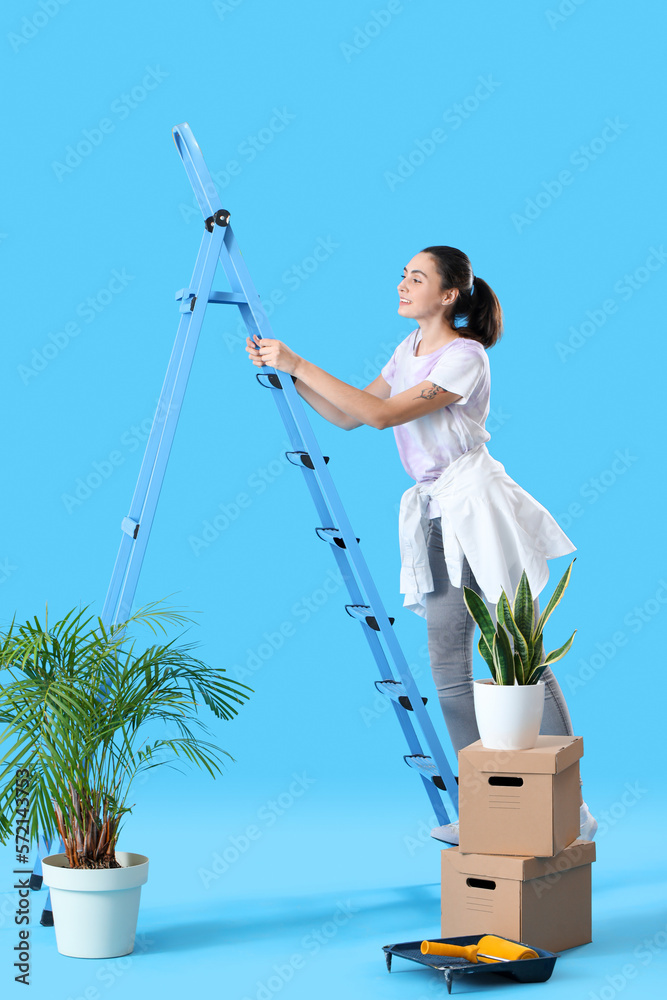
[441,736,595,951]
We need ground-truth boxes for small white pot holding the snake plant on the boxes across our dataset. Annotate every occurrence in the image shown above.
[473,680,545,750]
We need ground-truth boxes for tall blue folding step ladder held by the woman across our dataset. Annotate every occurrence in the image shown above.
[31,122,458,925]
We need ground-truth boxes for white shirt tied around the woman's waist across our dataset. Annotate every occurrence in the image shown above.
[398,444,575,618]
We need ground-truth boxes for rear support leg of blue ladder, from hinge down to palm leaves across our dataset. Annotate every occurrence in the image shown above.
[107,226,224,622]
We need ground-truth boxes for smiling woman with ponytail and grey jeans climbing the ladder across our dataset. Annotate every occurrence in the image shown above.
[246,246,597,843]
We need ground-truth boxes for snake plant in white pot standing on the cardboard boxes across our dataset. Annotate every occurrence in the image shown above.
[463,559,576,750]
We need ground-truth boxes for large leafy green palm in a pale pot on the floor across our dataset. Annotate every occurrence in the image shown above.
[0,602,251,958]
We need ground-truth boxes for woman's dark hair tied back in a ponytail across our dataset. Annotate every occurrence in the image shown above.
[421,247,503,348]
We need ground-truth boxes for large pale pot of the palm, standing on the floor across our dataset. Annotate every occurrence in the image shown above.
[42,851,148,958]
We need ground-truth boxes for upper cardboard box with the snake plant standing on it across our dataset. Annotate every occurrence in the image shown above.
[459,736,584,857]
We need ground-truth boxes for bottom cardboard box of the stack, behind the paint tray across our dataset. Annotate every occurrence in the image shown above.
[441,840,595,951]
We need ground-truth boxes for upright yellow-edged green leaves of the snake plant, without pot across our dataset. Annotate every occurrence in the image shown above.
[463,559,577,684]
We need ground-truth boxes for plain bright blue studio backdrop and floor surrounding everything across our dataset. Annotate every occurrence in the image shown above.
[0,0,667,1000]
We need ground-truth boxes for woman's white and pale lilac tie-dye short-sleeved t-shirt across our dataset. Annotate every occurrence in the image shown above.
[381,327,491,517]
